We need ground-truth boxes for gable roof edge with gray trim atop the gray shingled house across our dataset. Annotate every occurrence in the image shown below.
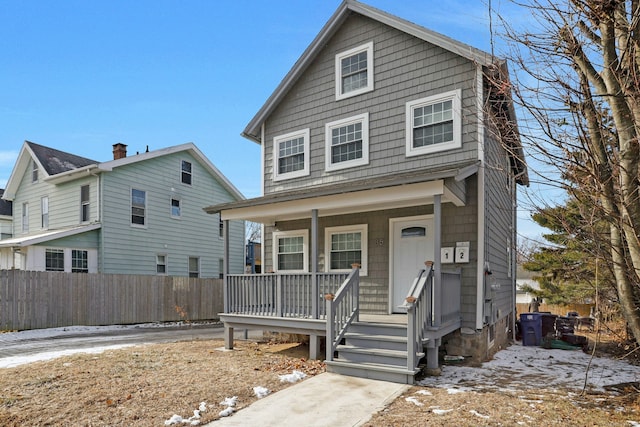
[242,0,501,143]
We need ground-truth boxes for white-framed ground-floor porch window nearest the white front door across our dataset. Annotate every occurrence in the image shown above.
[325,224,367,275]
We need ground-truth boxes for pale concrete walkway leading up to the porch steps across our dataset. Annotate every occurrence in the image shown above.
[206,373,409,427]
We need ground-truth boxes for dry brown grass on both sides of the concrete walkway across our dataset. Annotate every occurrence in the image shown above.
[0,332,640,427]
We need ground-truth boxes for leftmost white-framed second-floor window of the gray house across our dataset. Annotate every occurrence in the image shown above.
[273,129,309,181]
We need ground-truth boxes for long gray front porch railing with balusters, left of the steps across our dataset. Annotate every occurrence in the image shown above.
[224,273,349,319]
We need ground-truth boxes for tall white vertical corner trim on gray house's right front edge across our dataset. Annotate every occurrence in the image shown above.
[476,65,486,330]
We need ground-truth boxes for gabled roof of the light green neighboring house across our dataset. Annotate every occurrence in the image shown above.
[0,141,245,200]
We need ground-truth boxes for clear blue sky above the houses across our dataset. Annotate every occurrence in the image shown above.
[0,0,544,241]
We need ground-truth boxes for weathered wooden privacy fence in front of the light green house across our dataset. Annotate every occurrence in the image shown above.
[0,270,223,330]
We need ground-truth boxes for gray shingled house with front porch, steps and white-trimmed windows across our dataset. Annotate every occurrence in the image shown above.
[207,0,528,382]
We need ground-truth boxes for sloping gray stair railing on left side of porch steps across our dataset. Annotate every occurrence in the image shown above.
[325,268,360,361]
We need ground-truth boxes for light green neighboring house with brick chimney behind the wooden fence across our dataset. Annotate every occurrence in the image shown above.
[0,141,244,277]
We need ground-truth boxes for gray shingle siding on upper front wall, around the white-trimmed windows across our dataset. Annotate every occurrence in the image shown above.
[264,14,477,194]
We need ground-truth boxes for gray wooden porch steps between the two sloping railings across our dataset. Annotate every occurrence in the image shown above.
[326,322,420,384]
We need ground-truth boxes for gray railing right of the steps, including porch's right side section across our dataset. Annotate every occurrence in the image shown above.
[405,263,460,369]
